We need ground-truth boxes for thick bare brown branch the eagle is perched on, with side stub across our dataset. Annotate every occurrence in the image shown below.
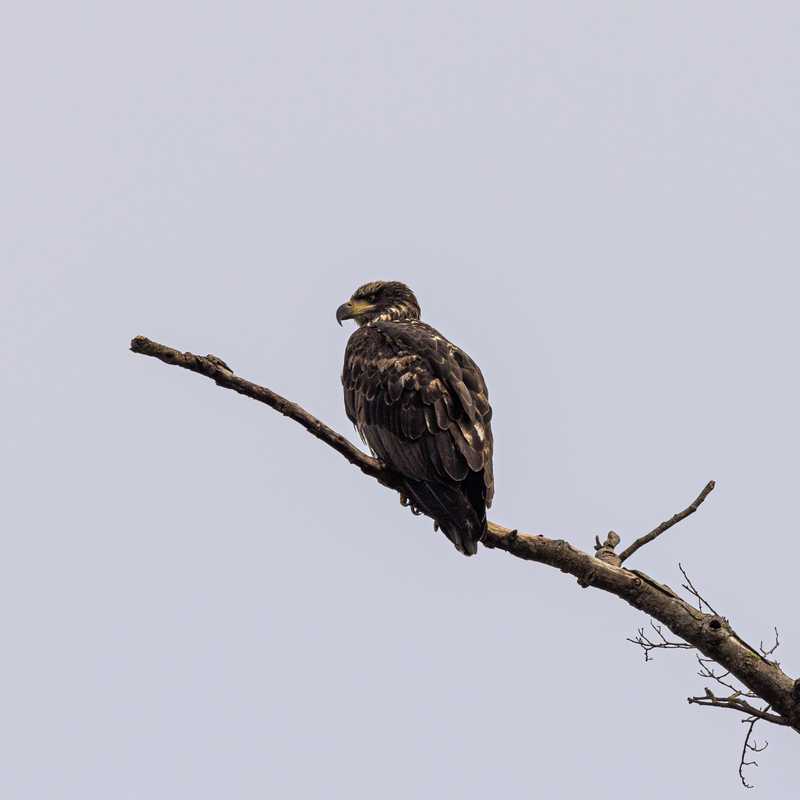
[131,336,800,732]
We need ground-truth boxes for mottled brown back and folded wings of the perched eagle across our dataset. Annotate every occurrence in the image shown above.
[342,322,494,505]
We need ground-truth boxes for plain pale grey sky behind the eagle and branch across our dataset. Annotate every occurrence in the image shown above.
[0,0,800,800]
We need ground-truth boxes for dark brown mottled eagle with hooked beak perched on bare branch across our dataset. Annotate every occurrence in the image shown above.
[336,281,494,556]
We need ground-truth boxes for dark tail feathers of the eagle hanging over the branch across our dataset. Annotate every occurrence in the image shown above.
[406,480,486,556]
